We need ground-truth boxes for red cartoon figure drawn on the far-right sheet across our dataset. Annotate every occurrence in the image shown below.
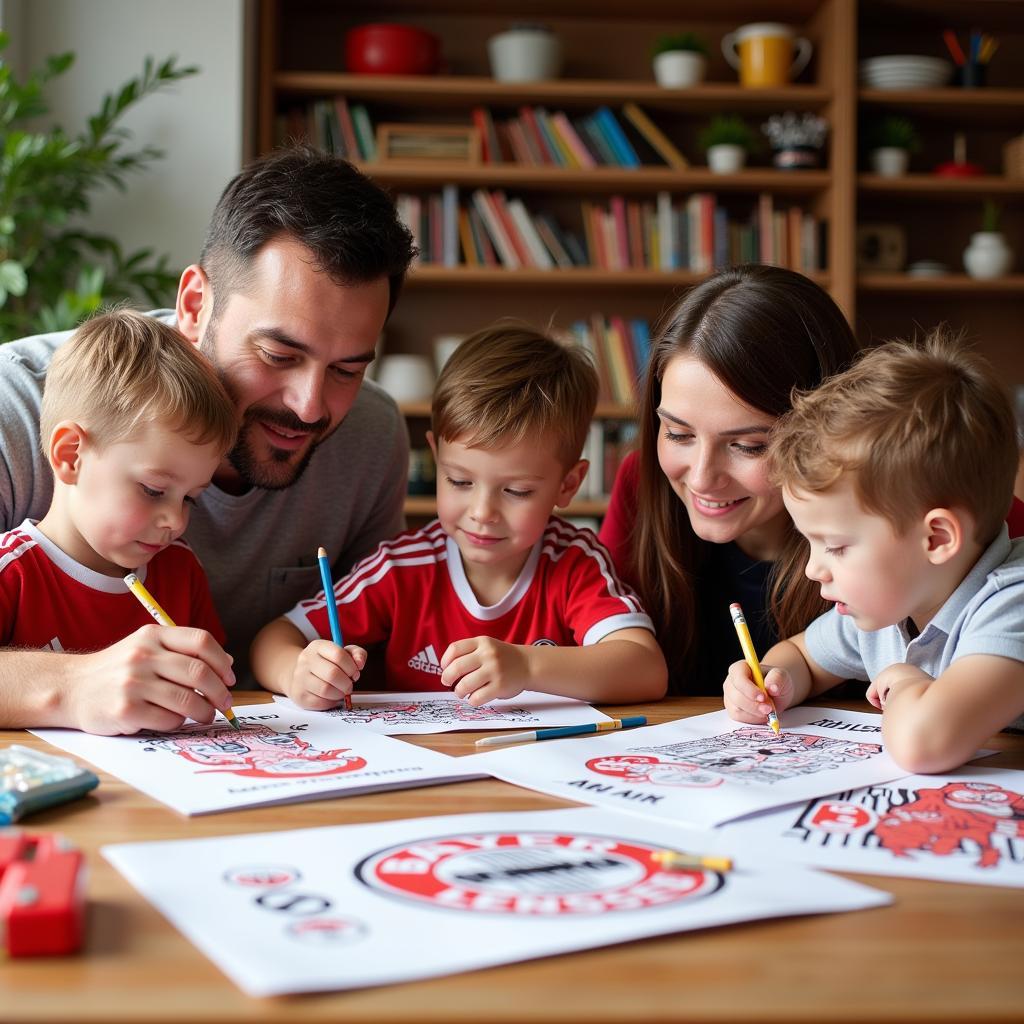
[874,782,1024,867]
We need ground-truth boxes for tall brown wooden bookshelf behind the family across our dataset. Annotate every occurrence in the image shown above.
[255,0,1024,528]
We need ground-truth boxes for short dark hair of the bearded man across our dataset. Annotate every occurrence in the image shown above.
[200,146,416,316]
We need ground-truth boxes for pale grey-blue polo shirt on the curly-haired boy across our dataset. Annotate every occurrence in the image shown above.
[805,526,1024,729]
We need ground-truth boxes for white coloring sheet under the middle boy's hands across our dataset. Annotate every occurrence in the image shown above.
[274,690,611,736]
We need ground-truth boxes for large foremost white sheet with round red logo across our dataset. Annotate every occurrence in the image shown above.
[102,808,892,995]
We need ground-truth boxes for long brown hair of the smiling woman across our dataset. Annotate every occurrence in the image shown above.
[633,264,858,679]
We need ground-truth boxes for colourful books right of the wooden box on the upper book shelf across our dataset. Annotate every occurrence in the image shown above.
[472,102,689,170]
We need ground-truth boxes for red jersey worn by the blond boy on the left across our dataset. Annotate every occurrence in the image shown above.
[0,519,224,652]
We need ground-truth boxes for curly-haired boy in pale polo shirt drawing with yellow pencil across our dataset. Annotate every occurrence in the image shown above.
[723,332,1024,772]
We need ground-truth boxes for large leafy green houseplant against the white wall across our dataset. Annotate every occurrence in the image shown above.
[0,33,199,342]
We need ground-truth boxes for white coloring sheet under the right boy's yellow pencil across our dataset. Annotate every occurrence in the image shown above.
[463,708,906,827]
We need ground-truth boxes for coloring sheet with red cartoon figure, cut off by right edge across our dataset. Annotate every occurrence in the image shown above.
[722,767,1024,888]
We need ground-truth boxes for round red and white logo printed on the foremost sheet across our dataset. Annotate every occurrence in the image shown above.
[355,831,724,918]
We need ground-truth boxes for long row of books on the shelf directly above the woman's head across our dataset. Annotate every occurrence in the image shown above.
[397,184,827,273]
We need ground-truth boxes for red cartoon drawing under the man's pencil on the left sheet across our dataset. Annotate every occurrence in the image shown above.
[146,724,367,778]
